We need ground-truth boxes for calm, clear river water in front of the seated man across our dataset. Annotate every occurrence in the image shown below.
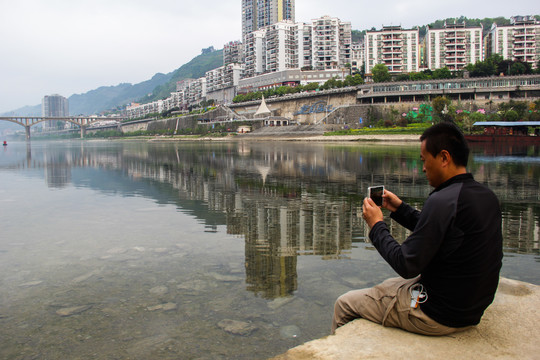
[0,141,540,359]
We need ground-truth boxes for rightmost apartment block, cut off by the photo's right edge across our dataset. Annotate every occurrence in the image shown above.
[486,16,540,68]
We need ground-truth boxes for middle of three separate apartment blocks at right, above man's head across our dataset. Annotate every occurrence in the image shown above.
[424,23,484,71]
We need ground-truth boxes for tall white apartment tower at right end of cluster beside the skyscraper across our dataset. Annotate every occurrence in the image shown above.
[311,16,352,70]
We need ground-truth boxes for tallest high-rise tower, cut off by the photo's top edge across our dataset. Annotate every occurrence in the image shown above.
[242,0,295,43]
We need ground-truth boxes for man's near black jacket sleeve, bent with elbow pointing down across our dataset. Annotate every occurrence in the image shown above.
[369,196,456,279]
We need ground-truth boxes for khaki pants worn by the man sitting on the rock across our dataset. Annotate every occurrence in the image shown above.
[332,278,469,335]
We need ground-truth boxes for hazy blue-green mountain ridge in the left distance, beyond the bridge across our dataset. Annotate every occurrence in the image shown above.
[0,48,223,117]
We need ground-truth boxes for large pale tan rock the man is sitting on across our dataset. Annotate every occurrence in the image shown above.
[274,278,540,360]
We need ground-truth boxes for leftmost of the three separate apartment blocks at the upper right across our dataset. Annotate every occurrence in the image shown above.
[364,26,420,74]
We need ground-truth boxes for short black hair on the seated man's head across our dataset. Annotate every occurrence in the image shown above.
[420,121,469,166]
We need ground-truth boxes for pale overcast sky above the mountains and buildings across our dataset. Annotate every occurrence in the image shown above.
[0,0,540,113]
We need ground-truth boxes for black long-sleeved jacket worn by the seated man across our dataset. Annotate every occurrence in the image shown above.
[369,174,503,327]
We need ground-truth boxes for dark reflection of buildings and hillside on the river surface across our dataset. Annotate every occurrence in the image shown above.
[5,143,540,299]
